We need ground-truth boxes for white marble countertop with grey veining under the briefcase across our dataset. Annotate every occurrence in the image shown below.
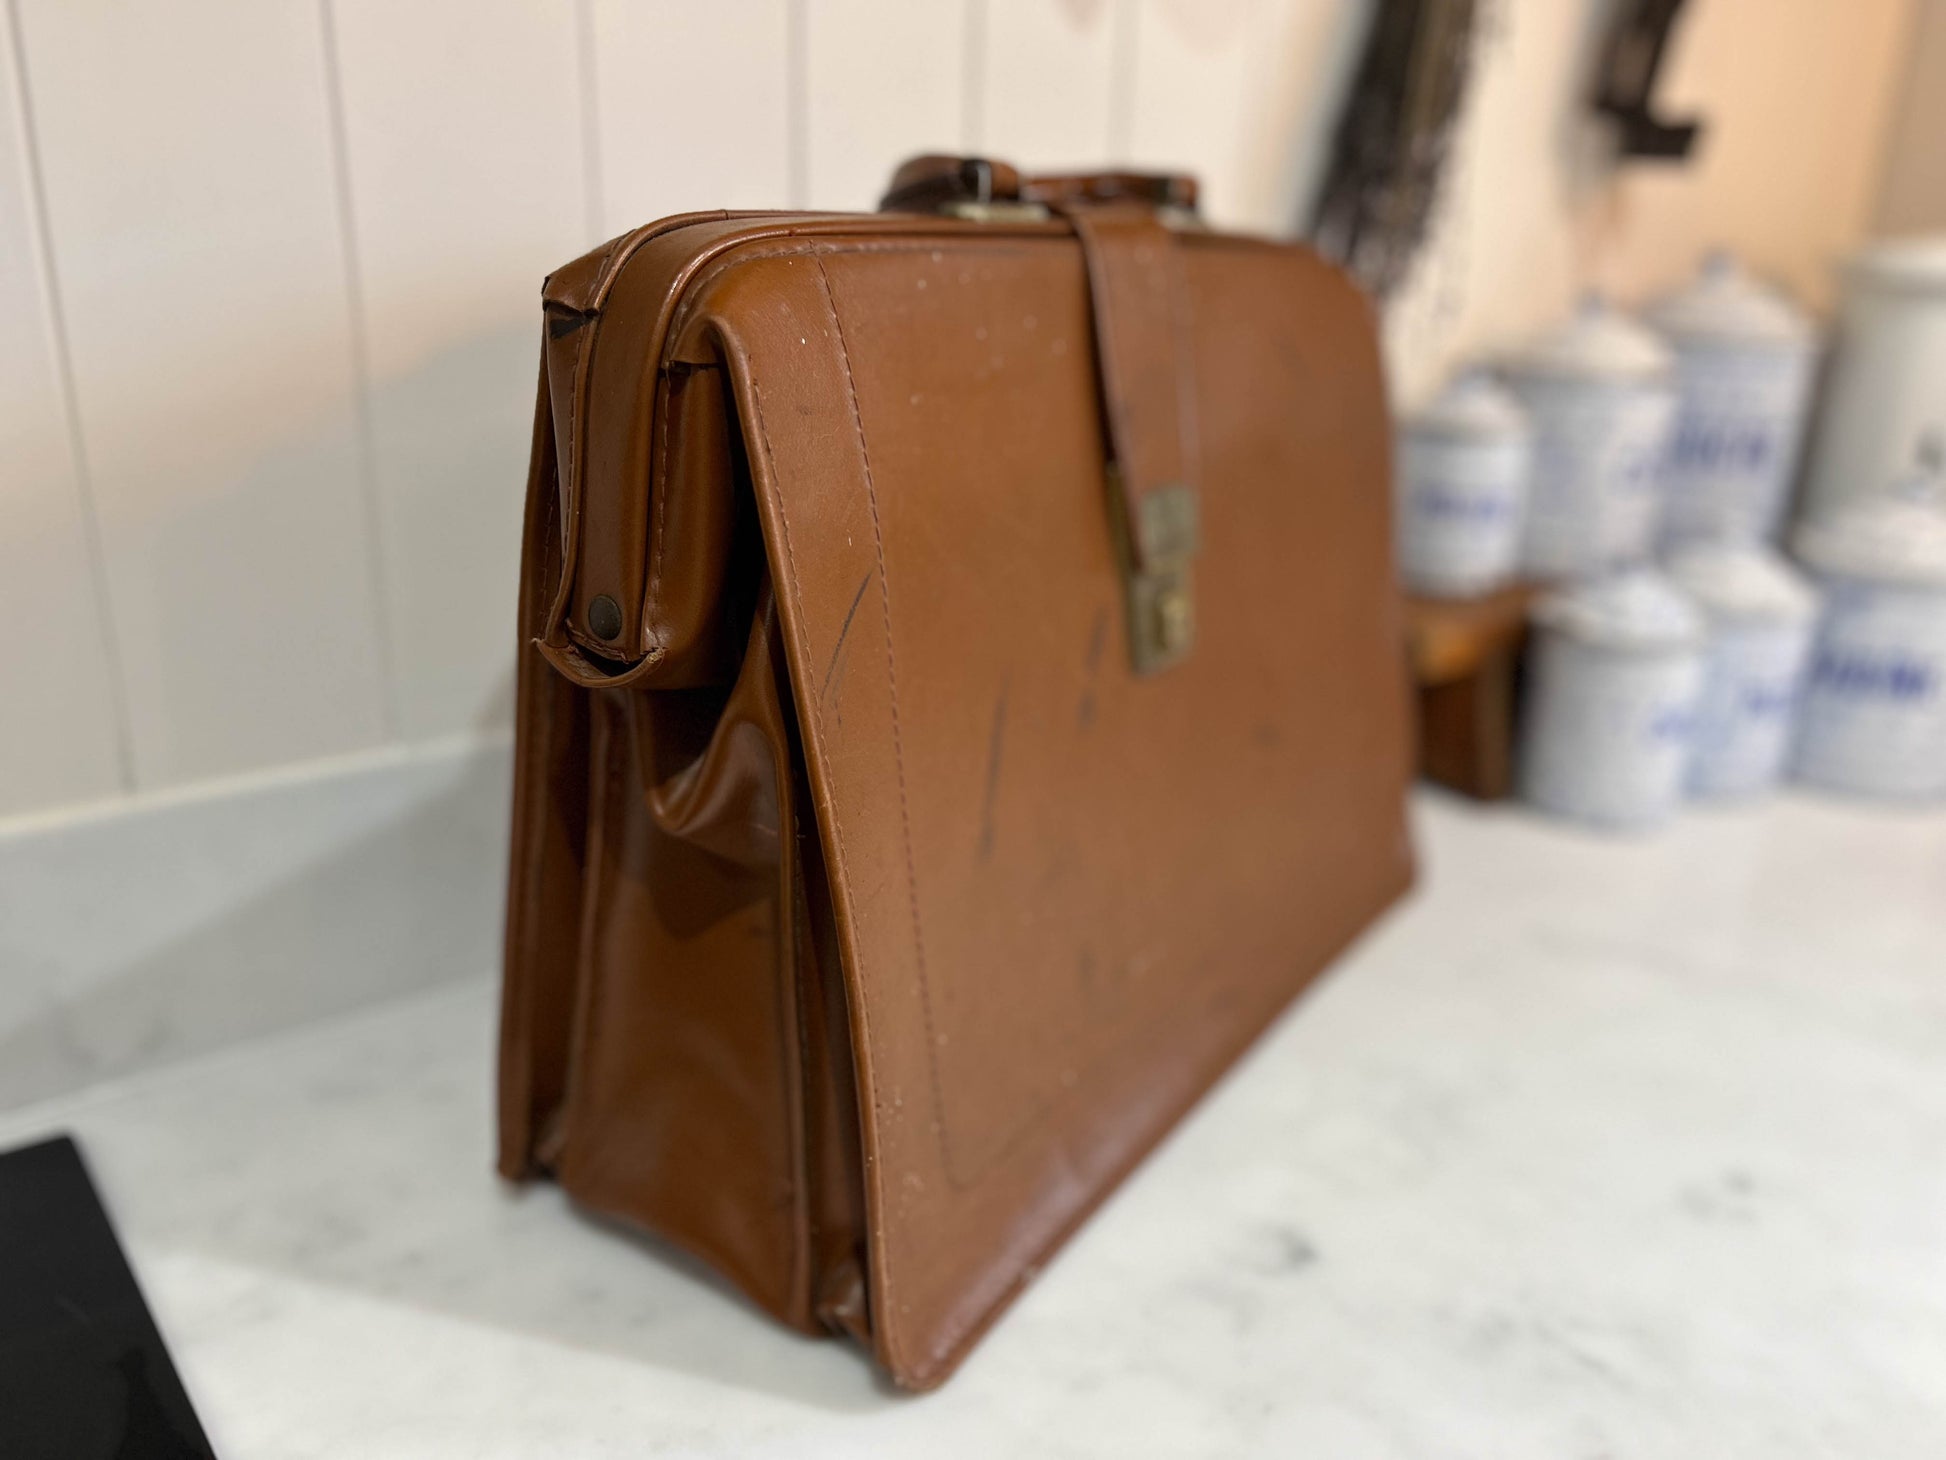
[0,798,1946,1460]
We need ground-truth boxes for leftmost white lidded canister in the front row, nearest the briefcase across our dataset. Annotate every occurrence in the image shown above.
[1520,568,1705,829]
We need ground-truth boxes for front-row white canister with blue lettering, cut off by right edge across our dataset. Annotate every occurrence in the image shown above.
[1796,463,1946,800]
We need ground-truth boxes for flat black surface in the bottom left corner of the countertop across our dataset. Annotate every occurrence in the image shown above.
[0,1137,214,1460]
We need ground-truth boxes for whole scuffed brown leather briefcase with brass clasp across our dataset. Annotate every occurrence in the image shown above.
[500,158,1411,1388]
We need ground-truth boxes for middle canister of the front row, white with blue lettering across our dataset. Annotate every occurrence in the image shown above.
[1668,541,1818,800]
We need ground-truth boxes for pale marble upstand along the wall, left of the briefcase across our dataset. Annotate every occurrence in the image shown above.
[0,736,512,1108]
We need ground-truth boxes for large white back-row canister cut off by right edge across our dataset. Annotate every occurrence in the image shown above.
[1804,234,1946,518]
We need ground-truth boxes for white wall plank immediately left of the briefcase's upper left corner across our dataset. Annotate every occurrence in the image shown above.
[325,0,592,740]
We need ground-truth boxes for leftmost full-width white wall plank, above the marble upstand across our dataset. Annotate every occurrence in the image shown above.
[18,0,391,802]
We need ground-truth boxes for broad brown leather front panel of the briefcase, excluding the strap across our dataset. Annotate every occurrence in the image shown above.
[671,220,1409,1386]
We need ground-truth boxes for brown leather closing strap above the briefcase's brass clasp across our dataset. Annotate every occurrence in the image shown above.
[1055,202,1197,568]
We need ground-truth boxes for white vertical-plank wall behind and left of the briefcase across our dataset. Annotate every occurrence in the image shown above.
[0,0,1370,818]
